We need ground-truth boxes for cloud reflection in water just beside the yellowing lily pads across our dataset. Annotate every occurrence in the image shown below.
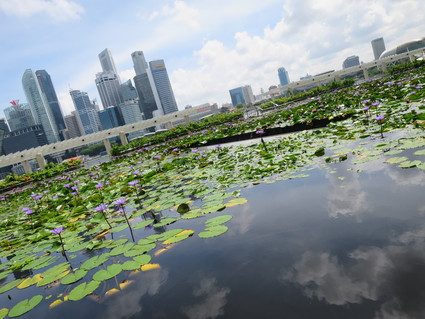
[102,268,168,319]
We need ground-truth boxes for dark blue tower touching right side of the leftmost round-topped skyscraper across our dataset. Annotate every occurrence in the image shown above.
[35,70,65,140]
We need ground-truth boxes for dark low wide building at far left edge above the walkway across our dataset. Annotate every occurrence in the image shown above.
[3,125,48,155]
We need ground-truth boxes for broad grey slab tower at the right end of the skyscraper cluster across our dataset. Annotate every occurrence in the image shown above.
[149,60,178,114]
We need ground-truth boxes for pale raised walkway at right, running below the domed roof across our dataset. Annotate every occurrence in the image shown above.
[268,48,425,96]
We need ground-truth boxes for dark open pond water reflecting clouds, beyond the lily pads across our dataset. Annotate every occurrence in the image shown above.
[1,144,425,319]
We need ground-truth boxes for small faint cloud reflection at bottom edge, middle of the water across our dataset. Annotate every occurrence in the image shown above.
[184,278,230,319]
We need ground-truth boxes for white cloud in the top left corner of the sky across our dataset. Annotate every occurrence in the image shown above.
[0,0,84,22]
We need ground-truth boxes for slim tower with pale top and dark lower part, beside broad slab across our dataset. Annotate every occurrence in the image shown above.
[131,51,162,119]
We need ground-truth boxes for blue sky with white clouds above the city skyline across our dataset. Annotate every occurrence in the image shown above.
[0,0,425,116]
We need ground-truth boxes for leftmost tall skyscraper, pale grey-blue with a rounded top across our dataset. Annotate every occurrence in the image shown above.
[22,69,59,143]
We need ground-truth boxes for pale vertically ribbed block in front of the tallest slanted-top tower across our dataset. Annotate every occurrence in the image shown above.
[95,72,124,109]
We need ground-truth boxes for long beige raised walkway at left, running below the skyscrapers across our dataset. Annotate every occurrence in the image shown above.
[0,107,202,173]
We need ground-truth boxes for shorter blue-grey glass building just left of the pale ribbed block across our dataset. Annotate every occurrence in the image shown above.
[69,90,100,134]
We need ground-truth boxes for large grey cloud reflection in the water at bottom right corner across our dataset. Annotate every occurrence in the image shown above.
[280,225,425,319]
